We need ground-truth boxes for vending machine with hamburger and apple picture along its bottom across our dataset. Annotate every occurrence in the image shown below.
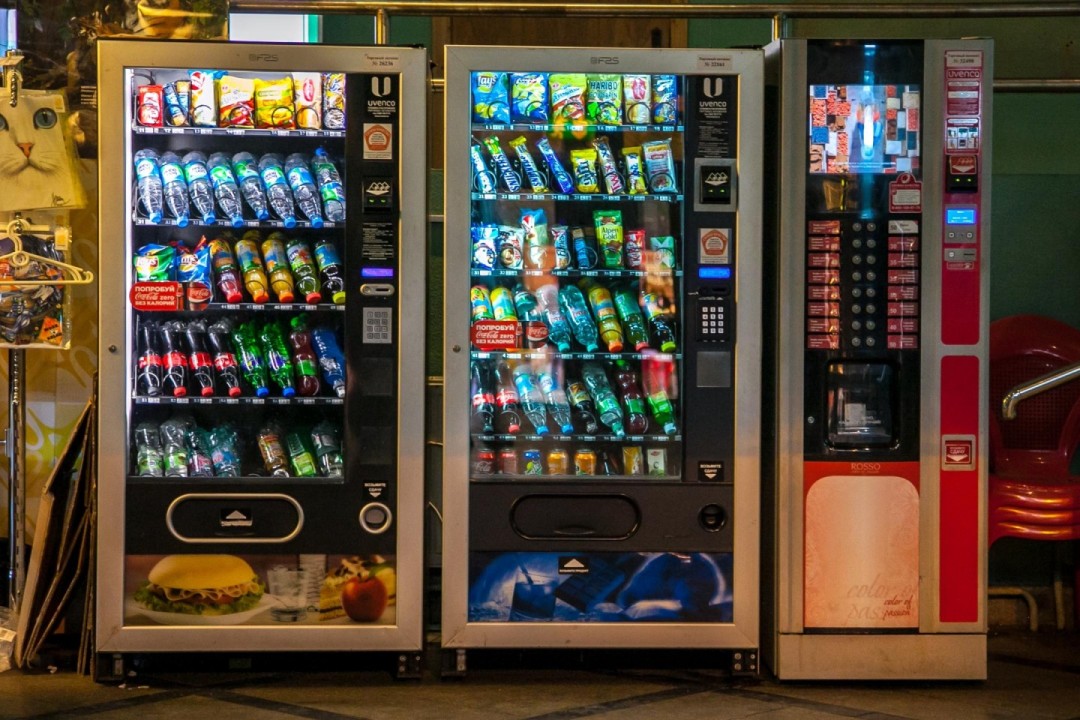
[97,40,427,677]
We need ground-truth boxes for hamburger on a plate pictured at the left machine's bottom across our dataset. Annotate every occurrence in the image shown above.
[135,555,266,615]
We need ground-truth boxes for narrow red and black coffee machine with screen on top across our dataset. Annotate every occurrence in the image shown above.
[764,40,994,679]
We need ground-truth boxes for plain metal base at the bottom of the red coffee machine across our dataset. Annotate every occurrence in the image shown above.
[775,635,986,680]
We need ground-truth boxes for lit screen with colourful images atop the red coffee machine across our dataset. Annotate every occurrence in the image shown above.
[809,85,920,177]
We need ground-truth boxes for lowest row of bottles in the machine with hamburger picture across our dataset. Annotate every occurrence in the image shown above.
[135,416,345,477]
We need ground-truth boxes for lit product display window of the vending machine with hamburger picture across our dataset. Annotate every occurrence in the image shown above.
[129,69,347,483]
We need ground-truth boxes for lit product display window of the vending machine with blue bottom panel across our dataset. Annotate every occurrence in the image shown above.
[469,71,684,481]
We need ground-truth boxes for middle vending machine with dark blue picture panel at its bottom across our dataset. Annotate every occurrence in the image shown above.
[442,46,764,671]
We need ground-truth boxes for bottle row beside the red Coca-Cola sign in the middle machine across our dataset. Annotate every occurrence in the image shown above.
[470,277,677,353]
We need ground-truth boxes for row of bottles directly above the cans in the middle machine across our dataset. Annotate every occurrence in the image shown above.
[471,357,678,437]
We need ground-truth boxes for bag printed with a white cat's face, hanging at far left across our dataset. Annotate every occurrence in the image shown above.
[0,89,86,213]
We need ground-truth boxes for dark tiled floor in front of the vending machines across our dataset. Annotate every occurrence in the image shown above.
[0,630,1080,720]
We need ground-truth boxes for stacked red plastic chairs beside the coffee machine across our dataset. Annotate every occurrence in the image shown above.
[988,315,1080,628]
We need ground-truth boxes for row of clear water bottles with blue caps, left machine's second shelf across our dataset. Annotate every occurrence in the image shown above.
[135,148,345,228]
